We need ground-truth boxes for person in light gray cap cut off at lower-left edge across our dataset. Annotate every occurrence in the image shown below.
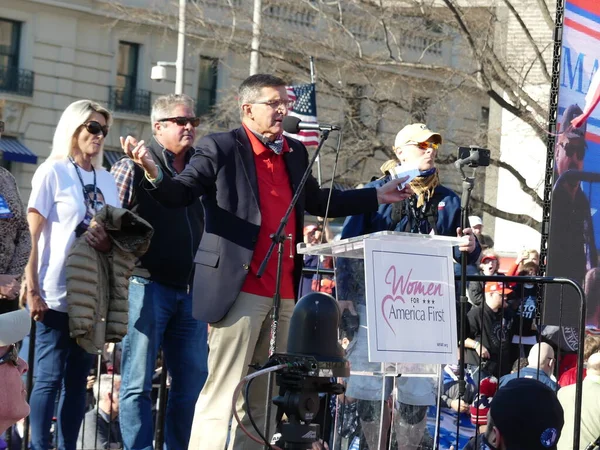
[0,309,31,435]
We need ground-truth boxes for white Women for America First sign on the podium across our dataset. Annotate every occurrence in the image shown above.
[364,236,458,364]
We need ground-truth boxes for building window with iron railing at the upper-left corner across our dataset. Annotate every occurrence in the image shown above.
[0,19,33,96]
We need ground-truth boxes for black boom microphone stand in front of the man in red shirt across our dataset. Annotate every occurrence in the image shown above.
[256,129,331,450]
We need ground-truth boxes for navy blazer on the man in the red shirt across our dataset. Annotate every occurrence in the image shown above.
[144,127,378,323]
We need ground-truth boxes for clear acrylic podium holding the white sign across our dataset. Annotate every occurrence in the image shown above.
[298,231,475,450]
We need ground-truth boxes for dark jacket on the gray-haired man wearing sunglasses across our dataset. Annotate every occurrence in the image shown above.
[124,142,204,288]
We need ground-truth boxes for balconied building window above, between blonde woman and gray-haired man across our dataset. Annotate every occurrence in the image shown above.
[109,42,150,115]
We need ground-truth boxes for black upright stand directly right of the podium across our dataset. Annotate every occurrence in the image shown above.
[455,161,477,448]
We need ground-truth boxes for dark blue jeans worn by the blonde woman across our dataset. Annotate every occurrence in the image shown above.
[29,309,94,450]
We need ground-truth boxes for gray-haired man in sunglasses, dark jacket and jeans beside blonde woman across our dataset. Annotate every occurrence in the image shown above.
[111,95,208,450]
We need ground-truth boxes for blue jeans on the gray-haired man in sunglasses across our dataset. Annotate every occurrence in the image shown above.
[119,277,208,450]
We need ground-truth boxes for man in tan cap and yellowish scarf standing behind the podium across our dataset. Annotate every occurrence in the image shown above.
[336,123,481,448]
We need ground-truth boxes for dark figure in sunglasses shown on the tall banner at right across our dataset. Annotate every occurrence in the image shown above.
[545,105,598,326]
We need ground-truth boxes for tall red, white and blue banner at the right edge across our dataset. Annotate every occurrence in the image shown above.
[544,0,600,338]
